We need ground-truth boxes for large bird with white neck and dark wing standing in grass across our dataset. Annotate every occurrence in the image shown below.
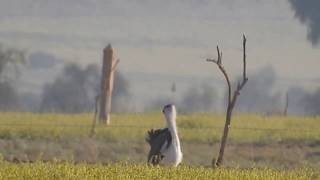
[146,104,182,166]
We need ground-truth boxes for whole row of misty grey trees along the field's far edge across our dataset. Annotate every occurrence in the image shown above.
[0,45,320,115]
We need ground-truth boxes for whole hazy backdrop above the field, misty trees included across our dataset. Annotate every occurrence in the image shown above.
[0,0,320,114]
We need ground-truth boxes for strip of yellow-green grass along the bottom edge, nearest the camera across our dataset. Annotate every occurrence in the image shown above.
[0,161,320,180]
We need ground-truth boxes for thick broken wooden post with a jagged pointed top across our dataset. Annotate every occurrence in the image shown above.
[99,44,119,125]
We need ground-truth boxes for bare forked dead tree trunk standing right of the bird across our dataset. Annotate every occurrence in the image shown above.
[207,35,248,167]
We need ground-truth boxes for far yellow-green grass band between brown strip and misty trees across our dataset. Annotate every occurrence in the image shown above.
[0,112,320,143]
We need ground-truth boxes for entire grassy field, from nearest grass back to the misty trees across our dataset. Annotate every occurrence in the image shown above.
[0,112,320,180]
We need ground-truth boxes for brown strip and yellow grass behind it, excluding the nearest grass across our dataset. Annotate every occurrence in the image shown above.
[0,112,320,169]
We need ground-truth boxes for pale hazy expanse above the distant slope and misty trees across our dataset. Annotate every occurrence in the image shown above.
[0,0,320,102]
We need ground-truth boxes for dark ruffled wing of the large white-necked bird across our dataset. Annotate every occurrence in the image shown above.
[146,128,172,165]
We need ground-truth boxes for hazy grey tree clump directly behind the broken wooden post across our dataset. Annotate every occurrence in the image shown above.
[40,63,129,113]
